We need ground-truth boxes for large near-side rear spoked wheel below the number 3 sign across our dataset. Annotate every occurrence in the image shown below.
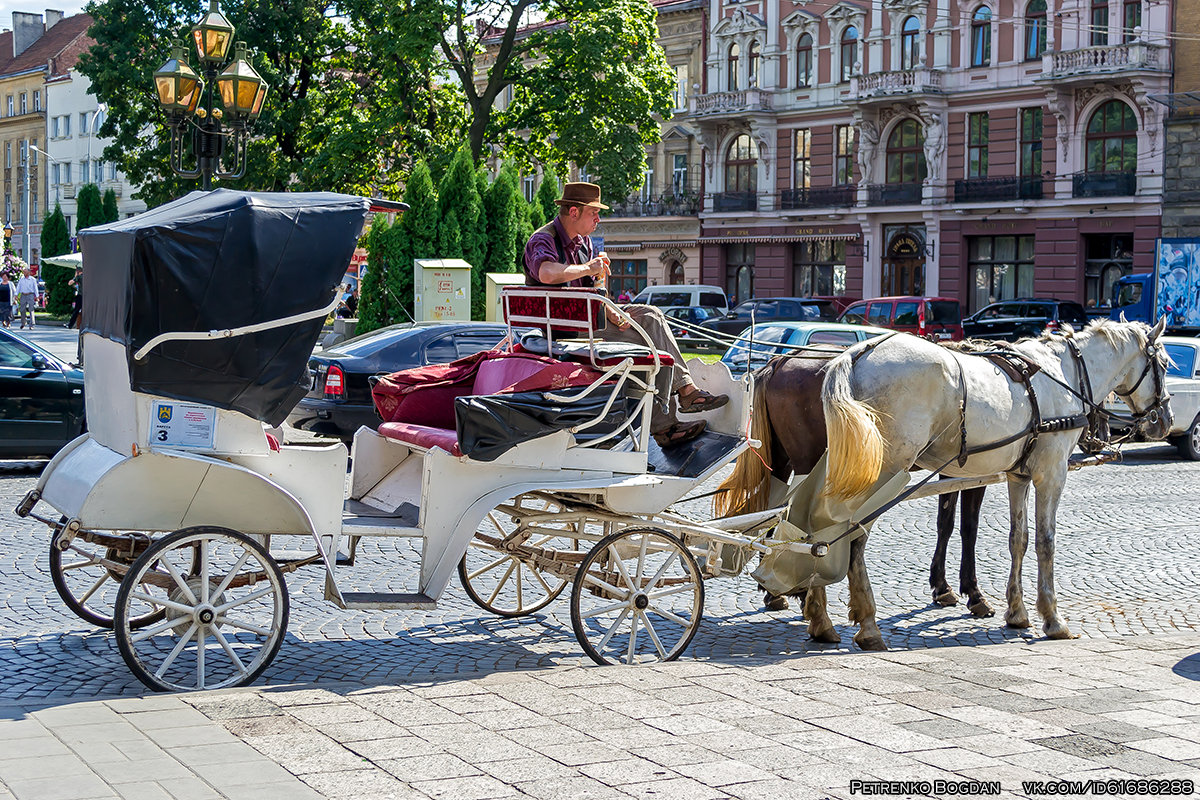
[115,527,288,691]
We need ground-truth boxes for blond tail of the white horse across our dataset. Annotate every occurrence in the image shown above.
[821,355,884,499]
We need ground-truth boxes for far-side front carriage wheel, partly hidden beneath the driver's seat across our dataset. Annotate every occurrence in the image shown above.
[458,495,578,616]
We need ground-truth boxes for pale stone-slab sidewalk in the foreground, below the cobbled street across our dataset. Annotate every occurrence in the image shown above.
[0,633,1200,800]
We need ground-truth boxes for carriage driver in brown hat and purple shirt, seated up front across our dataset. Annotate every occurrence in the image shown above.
[523,182,730,447]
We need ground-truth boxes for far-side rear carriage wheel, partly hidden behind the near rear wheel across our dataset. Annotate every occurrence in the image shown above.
[49,525,196,630]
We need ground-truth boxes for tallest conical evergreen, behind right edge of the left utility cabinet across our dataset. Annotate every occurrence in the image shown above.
[438,148,485,319]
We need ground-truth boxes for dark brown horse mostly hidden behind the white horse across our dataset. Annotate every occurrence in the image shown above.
[714,345,992,642]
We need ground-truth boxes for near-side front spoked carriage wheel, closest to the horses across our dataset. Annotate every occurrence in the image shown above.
[571,528,704,664]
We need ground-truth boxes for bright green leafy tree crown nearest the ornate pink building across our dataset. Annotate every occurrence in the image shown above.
[437,0,674,197]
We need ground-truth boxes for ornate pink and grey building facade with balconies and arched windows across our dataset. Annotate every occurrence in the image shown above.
[689,0,1172,313]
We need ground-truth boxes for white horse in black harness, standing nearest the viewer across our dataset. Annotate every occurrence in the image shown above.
[822,318,1171,650]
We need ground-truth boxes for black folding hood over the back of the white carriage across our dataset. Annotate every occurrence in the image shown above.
[80,190,370,425]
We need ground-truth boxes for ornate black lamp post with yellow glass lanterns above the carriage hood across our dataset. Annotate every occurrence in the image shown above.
[154,0,266,191]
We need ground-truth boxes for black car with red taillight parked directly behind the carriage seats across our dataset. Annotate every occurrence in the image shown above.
[288,323,509,441]
